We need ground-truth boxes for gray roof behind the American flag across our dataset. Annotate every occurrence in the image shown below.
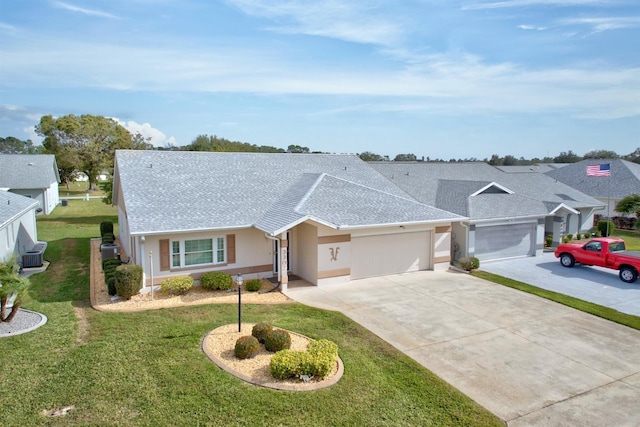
[545,159,640,199]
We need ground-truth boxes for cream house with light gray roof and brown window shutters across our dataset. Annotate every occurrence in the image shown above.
[113,150,465,287]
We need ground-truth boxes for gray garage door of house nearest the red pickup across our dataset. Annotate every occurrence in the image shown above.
[475,223,536,261]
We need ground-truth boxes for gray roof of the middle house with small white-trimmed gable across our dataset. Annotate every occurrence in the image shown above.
[372,162,602,220]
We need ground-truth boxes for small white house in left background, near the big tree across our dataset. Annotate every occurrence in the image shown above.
[0,154,60,215]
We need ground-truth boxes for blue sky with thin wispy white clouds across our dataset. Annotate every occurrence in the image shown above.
[0,0,640,159]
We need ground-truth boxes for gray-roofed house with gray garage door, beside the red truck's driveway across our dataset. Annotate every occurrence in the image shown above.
[371,162,603,261]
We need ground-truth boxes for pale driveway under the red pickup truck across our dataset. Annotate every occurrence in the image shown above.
[480,252,640,316]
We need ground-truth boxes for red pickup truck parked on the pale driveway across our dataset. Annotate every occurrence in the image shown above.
[555,237,640,283]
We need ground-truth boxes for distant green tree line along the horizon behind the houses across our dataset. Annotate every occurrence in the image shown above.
[0,118,640,190]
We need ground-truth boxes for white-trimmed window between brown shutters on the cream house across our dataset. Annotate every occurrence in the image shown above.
[171,237,227,267]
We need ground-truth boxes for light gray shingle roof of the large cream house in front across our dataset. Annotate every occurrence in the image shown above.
[114,150,462,234]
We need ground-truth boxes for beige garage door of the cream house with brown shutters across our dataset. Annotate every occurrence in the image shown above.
[351,231,431,279]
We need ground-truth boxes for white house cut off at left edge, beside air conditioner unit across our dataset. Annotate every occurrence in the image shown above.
[0,191,39,262]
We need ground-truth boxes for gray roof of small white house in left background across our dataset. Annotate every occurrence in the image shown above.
[0,154,60,190]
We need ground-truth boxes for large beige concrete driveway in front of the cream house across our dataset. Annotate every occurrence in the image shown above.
[286,271,640,426]
